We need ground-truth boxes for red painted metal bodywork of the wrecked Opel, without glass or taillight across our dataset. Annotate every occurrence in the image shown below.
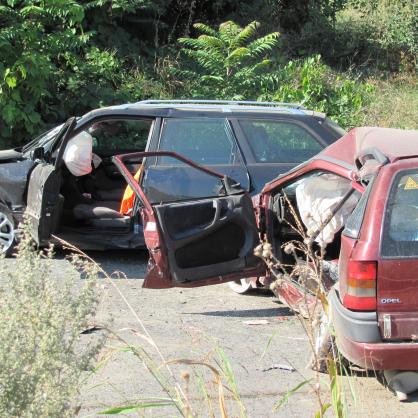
[114,128,418,370]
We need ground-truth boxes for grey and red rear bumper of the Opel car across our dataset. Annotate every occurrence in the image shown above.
[329,288,418,370]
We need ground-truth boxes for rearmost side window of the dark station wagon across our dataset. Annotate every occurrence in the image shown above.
[239,120,325,163]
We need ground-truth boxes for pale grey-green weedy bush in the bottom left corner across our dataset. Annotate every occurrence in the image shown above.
[0,225,101,418]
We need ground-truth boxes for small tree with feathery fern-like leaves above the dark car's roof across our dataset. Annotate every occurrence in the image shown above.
[178,21,279,100]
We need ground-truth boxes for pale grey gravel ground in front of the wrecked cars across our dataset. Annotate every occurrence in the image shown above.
[4,252,418,418]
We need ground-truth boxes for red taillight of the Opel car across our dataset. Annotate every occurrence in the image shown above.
[343,260,377,311]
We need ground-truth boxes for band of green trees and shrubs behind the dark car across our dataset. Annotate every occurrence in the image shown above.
[0,0,418,147]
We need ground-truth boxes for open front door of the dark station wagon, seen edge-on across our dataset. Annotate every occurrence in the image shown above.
[26,118,76,246]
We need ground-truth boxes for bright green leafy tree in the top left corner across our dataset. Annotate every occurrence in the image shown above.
[0,0,88,144]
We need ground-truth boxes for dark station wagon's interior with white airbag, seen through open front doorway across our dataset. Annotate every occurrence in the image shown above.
[50,120,152,249]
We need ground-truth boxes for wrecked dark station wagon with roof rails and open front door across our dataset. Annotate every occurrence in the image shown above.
[0,101,344,254]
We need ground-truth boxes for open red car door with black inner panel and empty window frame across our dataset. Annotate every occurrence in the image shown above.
[114,151,262,288]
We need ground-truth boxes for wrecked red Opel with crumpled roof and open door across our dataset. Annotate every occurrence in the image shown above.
[114,128,418,370]
